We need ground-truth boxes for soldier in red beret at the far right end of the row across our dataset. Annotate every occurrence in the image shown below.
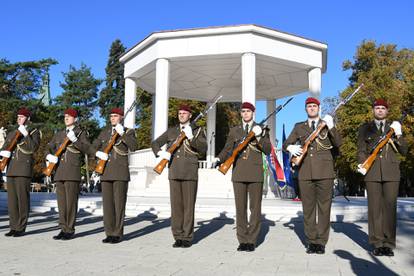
[358,99,408,256]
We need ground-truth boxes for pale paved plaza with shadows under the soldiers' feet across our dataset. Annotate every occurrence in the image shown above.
[0,208,414,275]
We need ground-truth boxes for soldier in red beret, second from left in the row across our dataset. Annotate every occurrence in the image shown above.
[46,108,90,240]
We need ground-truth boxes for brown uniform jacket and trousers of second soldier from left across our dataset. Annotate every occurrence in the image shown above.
[47,126,91,234]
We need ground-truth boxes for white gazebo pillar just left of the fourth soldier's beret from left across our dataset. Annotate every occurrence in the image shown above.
[153,58,170,139]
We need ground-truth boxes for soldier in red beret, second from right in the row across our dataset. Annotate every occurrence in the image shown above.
[283,97,341,254]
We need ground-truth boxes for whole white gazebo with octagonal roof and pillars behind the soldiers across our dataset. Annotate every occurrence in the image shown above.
[120,25,327,198]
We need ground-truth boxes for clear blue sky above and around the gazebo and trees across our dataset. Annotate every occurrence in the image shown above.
[0,0,414,145]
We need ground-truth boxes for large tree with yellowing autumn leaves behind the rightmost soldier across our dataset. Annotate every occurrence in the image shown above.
[327,41,414,194]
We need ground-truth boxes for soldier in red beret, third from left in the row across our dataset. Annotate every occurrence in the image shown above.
[93,108,137,243]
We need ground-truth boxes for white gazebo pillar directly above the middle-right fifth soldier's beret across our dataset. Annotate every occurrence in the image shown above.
[241,53,256,106]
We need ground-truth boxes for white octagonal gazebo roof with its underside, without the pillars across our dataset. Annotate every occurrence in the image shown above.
[120,25,327,101]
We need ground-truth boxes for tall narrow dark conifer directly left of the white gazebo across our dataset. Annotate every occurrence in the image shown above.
[98,39,126,120]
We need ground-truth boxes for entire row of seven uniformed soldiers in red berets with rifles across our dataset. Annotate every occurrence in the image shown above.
[0,89,408,256]
